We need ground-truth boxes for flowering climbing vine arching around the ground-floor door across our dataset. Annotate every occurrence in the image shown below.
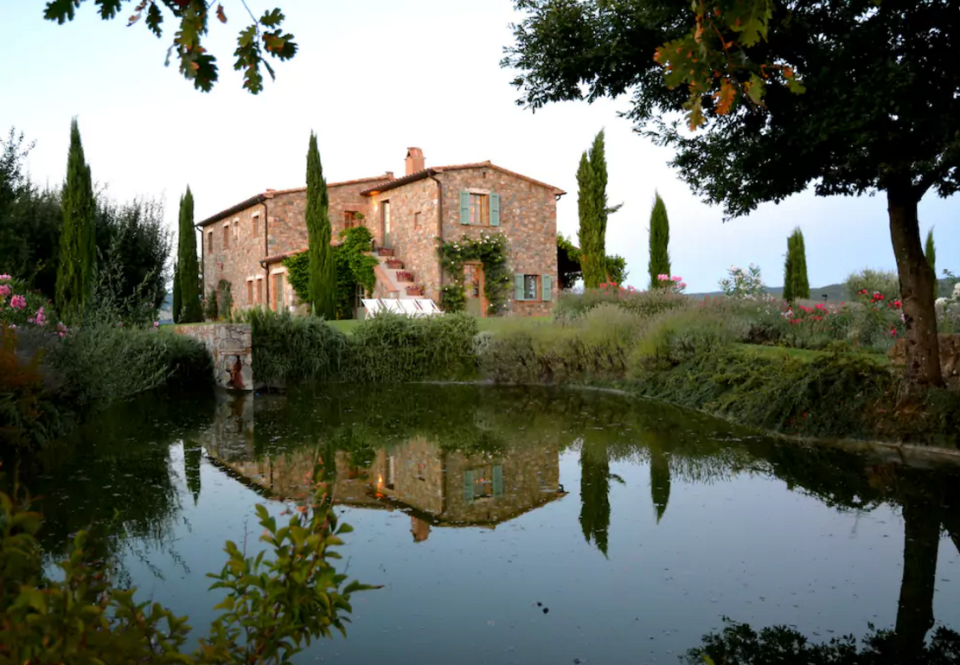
[440,233,511,316]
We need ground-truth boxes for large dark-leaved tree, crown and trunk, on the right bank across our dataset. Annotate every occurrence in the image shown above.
[504,0,960,394]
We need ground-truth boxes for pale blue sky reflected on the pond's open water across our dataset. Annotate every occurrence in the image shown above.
[114,436,960,664]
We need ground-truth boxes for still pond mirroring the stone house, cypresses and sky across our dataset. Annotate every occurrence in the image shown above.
[7,385,960,665]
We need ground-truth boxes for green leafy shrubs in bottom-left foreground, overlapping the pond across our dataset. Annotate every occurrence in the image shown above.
[0,456,378,665]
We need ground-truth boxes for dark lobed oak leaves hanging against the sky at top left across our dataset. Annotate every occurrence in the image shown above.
[43,0,297,94]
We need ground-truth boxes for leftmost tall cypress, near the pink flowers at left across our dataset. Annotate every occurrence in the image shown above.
[56,118,97,322]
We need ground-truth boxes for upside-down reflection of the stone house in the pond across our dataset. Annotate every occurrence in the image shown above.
[202,438,565,542]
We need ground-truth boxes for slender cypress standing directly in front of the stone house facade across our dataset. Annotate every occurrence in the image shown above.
[306,132,337,321]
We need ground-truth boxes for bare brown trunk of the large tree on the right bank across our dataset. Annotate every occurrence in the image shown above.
[887,186,943,398]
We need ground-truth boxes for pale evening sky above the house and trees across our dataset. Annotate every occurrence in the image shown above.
[0,0,960,291]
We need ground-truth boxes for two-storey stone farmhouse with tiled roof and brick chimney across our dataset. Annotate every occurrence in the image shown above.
[197,148,565,316]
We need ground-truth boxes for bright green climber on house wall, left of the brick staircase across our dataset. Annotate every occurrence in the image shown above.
[283,226,377,319]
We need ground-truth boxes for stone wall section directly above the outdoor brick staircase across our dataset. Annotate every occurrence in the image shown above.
[370,178,440,303]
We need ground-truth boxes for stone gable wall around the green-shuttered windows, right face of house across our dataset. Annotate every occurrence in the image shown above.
[437,167,559,316]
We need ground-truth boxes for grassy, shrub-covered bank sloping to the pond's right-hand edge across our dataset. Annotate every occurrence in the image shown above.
[478,294,960,448]
